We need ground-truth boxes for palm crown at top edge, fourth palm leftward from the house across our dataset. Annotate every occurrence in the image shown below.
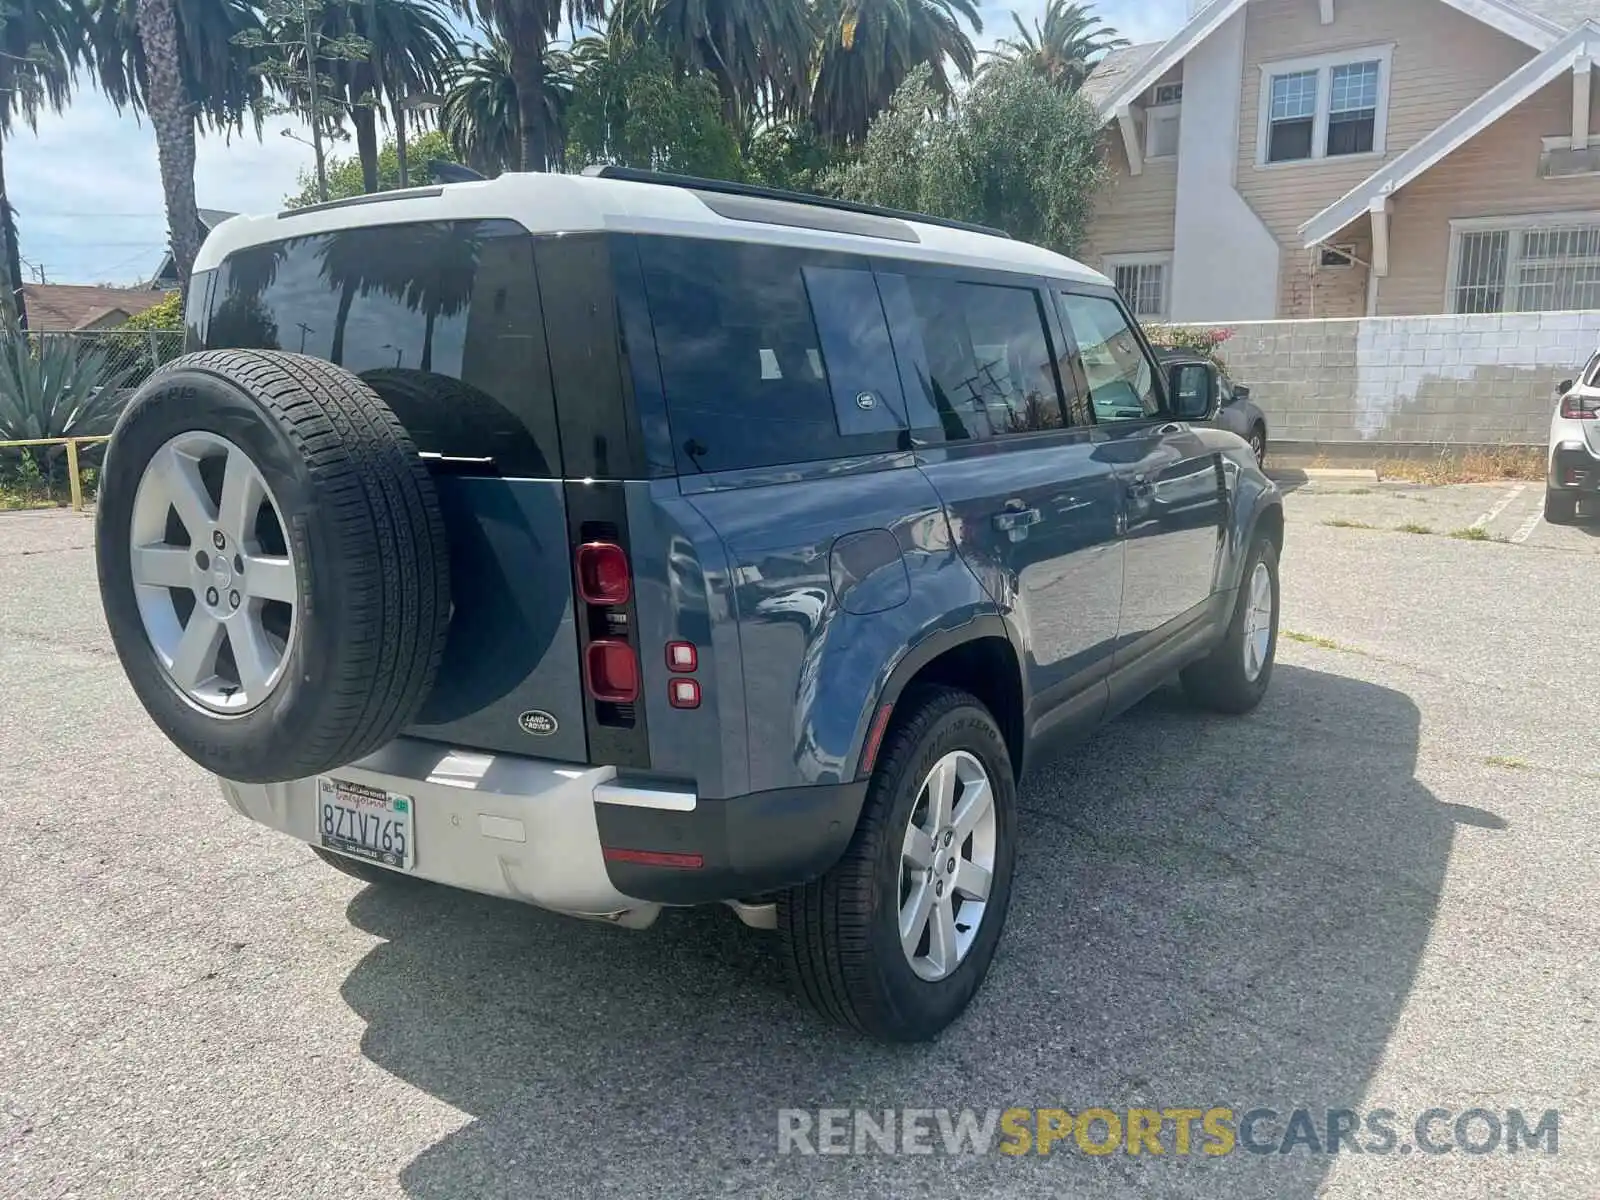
[611,0,816,131]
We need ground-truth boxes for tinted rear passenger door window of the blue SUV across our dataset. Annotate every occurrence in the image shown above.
[878,274,1066,440]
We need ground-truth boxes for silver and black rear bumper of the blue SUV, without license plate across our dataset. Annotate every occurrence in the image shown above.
[221,738,866,917]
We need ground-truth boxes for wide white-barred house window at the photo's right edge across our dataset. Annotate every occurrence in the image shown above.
[1450,213,1600,312]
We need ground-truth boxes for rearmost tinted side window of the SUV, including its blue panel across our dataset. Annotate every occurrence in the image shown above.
[640,238,902,472]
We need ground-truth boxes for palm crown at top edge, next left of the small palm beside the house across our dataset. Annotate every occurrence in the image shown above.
[811,0,984,142]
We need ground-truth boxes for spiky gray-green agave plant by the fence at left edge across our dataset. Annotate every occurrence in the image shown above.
[0,322,128,489]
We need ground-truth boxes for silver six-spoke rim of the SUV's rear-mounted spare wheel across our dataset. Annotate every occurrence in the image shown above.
[128,430,299,714]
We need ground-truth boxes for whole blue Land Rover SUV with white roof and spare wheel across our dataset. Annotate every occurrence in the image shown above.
[98,170,1283,1040]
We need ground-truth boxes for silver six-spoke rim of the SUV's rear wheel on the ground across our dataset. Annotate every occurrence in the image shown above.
[899,750,1000,982]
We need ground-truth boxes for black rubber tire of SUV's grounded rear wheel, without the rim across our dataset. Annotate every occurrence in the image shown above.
[778,688,1018,1042]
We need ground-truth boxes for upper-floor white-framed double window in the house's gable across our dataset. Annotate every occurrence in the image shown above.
[1256,45,1394,166]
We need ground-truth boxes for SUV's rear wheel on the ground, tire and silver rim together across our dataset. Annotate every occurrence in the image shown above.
[778,688,1018,1042]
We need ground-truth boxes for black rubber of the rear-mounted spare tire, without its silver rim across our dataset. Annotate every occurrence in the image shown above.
[96,350,450,782]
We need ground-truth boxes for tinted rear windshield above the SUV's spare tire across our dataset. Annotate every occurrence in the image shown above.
[205,221,560,478]
